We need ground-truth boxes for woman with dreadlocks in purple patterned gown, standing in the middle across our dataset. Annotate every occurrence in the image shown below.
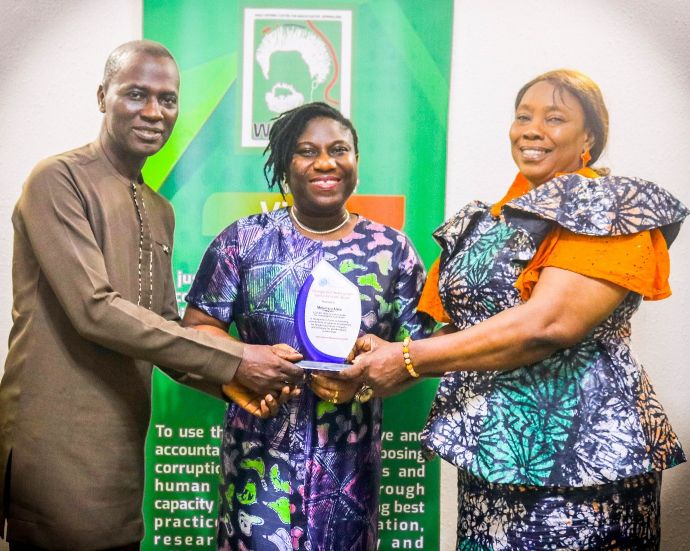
[185,103,434,551]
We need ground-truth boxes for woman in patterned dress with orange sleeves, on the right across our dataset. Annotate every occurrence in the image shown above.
[342,70,688,550]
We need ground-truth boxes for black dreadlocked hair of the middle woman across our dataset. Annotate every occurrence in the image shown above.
[264,101,359,197]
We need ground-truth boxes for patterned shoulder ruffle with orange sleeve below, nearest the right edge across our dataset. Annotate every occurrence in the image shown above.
[503,174,690,300]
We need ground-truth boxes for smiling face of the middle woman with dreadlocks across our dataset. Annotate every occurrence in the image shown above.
[287,117,357,217]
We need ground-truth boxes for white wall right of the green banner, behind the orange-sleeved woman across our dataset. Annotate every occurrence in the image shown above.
[442,0,690,551]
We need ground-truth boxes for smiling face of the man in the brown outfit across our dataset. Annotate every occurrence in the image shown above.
[98,52,180,175]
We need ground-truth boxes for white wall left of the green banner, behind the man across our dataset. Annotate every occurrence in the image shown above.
[0,0,141,360]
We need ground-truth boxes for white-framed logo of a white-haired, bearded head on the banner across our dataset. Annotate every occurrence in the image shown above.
[242,8,352,147]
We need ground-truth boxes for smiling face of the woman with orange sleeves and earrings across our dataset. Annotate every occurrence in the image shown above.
[510,81,592,186]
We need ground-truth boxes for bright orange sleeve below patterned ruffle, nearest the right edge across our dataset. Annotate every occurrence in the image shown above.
[515,226,671,300]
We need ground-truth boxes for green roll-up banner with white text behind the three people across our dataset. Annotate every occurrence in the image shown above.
[142,0,453,551]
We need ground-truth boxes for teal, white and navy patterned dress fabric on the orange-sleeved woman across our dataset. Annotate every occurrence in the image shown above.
[422,175,688,550]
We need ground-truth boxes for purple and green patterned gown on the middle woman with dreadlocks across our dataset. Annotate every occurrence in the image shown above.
[187,209,430,551]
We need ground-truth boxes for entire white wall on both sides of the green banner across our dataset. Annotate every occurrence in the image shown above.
[0,0,690,551]
